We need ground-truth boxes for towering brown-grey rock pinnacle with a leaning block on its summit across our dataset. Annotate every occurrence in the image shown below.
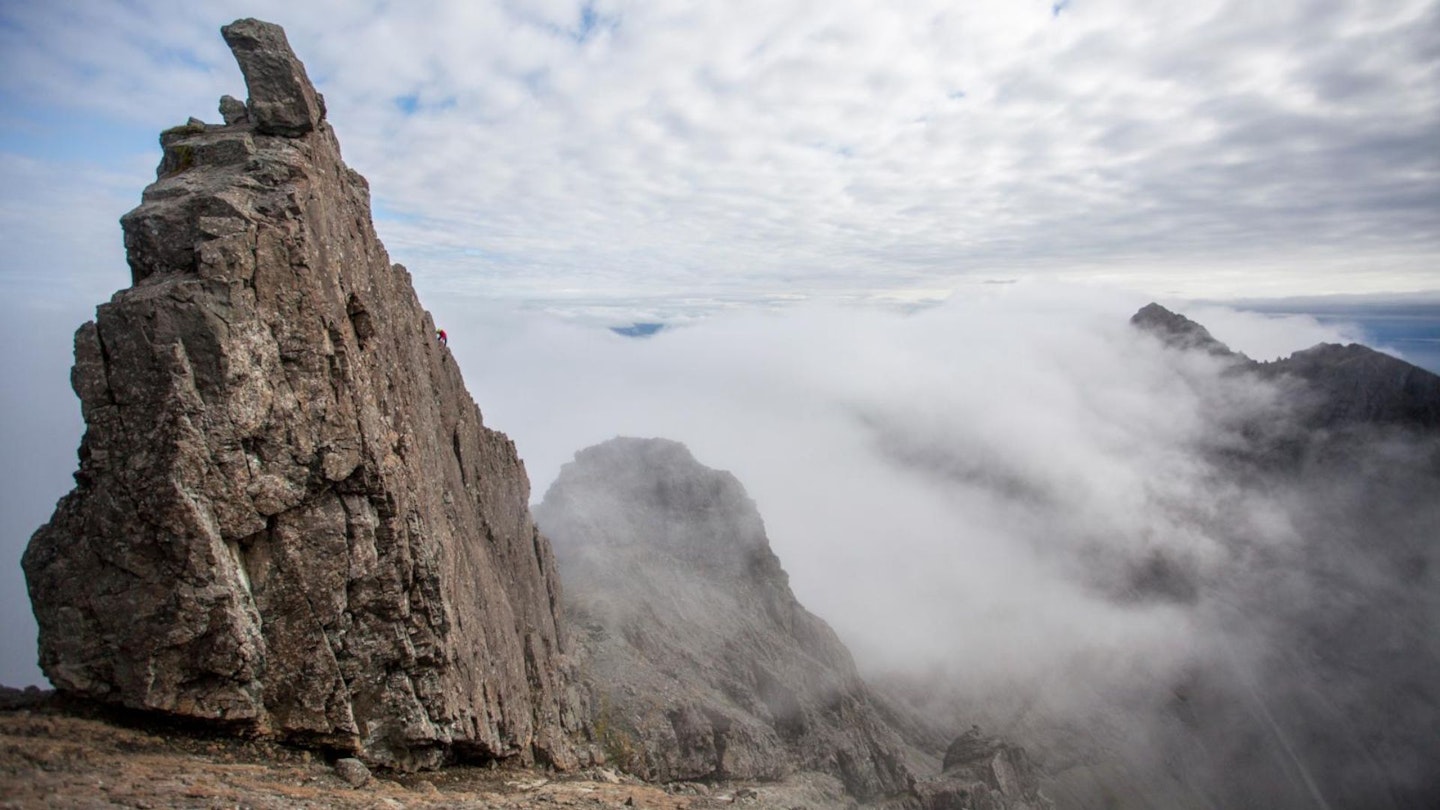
[23,20,582,767]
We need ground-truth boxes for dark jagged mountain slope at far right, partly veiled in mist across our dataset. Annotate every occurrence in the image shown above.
[1059,304,1440,810]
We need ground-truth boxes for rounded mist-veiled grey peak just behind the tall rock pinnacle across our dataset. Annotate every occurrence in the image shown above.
[536,438,913,797]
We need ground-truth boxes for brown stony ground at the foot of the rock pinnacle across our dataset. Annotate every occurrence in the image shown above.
[0,690,851,810]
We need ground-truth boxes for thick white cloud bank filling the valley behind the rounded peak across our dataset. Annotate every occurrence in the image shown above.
[439,284,1324,677]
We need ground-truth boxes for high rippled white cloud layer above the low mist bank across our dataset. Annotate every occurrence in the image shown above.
[0,0,1440,307]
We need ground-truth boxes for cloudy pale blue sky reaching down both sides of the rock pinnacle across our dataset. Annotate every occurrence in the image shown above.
[0,0,1440,683]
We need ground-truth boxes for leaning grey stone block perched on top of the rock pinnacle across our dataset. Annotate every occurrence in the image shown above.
[220,19,325,137]
